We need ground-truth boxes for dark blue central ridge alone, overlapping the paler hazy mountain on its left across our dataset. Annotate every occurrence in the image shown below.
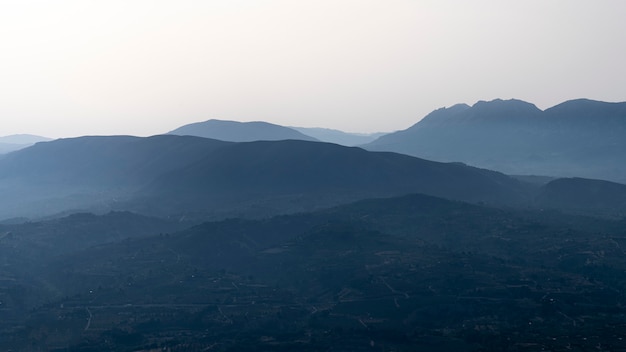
[138,140,527,216]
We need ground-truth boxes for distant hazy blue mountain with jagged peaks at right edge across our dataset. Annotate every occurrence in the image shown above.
[364,99,626,182]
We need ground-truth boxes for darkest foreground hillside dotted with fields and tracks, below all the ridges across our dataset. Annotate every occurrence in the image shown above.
[0,195,626,351]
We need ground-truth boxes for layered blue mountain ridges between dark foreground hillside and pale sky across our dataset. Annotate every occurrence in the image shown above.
[0,100,626,219]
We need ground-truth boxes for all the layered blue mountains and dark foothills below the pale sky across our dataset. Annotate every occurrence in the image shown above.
[0,100,626,352]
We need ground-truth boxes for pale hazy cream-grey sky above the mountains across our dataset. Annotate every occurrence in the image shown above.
[0,0,626,137]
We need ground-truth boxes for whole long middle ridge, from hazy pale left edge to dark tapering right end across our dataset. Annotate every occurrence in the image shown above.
[0,135,527,218]
